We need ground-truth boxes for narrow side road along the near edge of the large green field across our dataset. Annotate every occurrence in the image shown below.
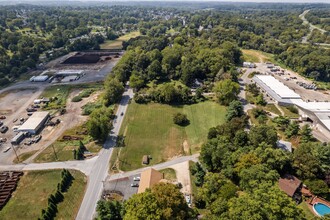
[107,154,199,181]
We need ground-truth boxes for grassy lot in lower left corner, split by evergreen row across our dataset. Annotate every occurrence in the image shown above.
[0,170,86,220]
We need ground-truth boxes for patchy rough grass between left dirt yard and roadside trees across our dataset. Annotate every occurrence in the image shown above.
[34,124,102,163]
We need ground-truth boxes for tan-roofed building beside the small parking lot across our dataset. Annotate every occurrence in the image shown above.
[138,168,164,193]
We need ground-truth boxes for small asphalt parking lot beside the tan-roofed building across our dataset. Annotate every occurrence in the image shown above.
[104,175,140,200]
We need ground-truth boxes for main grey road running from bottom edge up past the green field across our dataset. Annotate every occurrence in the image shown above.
[76,89,133,220]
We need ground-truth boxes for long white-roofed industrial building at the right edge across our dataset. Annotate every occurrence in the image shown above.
[252,75,330,134]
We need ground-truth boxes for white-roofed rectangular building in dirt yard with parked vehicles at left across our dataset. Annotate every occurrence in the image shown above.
[17,112,49,134]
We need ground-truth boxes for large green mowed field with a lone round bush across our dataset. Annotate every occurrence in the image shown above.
[112,101,226,171]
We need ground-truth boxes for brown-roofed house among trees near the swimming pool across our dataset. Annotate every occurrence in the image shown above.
[278,174,302,203]
